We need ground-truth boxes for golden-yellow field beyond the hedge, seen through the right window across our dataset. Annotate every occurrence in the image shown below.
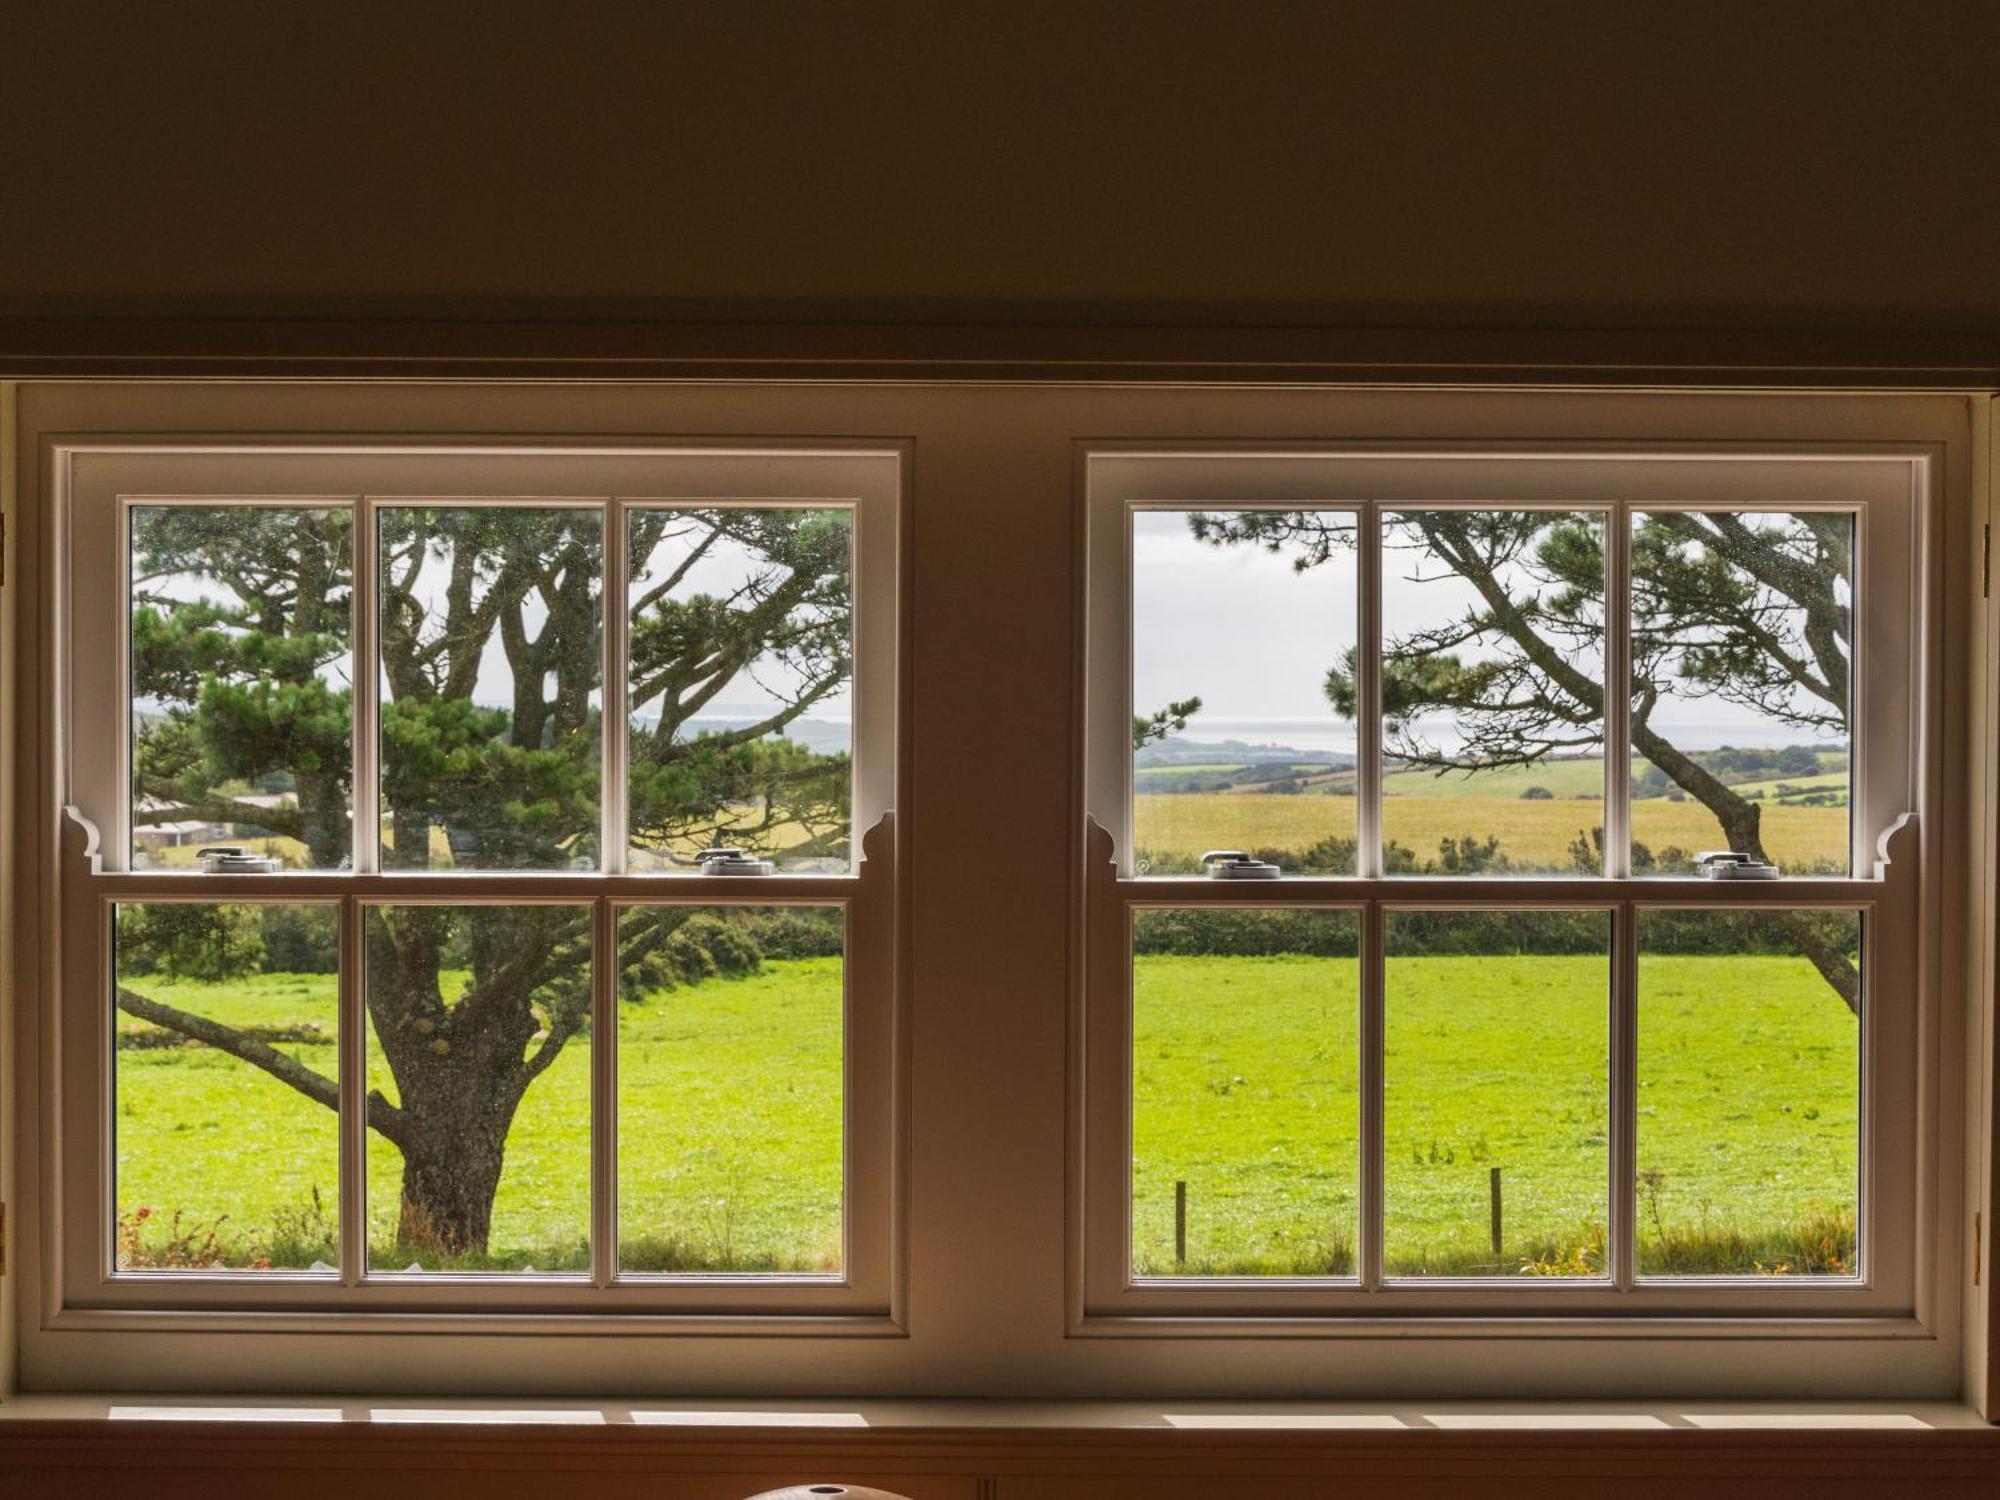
[1132,792,1848,870]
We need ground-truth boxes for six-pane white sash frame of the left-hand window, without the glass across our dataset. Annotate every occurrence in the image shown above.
[44,440,908,1334]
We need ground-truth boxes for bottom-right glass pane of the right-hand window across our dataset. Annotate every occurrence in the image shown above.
[1638,910,1862,1276]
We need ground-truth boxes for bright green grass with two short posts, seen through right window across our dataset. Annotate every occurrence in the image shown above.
[1132,954,1860,1276]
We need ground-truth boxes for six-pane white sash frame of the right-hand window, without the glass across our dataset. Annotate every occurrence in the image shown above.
[1072,442,1938,1336]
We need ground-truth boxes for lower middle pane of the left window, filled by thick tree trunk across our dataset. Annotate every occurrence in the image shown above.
[362,906,590,1272]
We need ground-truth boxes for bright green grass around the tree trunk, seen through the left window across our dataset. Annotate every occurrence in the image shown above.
[116,958,842,1272]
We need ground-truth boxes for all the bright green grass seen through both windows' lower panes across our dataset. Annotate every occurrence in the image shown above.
[116,956,1858,1274]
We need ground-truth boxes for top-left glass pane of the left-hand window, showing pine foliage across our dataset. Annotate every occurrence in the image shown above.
[130,506,354,870]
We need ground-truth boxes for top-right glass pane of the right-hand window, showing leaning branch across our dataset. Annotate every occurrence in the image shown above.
[1632,512,1854,874]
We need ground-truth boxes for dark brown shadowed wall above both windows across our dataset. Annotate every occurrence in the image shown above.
[0,0,2000,332]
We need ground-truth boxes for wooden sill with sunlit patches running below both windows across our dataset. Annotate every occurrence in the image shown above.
[0,1396,2000,1500]
